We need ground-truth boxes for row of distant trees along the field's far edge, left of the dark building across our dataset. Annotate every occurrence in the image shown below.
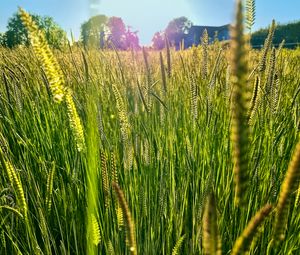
[0,13,192,50]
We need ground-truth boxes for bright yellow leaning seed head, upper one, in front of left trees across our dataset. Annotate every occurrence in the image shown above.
[19,8,65,103]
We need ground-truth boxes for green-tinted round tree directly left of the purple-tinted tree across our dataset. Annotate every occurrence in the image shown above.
[81,15,108,48]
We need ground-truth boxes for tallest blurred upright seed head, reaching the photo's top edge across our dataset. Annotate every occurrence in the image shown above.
[231,0,249,205]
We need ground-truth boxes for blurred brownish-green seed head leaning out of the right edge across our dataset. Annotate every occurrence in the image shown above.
[273,142,300,241]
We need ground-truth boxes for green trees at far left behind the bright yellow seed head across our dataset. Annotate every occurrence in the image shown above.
[5,13,67,48]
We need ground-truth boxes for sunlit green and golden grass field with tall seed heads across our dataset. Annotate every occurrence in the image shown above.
[0,3,300,255]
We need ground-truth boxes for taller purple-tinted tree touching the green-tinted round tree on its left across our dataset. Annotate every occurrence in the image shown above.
[107,17,126,50]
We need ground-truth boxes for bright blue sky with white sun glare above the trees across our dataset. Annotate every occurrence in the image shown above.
[0,0,300,45]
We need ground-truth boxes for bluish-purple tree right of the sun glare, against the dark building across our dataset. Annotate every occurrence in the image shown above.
[165,17,193,47]
